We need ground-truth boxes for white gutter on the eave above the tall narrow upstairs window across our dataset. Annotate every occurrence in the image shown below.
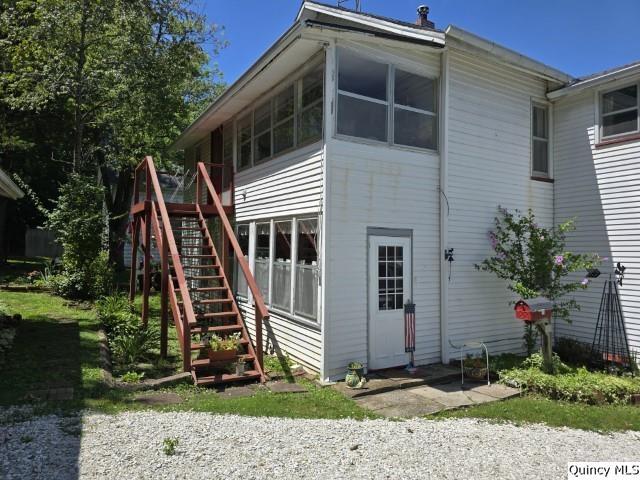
[445,25,573,83]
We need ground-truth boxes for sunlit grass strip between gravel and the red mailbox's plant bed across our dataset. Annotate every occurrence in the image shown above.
[435,396,640,432]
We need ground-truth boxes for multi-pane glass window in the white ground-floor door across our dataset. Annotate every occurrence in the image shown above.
[378,246,404,310]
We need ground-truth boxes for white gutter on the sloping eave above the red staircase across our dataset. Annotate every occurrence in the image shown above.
[169,22,304,150]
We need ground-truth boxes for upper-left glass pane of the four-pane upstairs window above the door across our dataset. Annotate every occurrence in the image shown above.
[338,50,388,100]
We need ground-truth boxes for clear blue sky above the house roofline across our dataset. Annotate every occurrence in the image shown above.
[200,0,640,83]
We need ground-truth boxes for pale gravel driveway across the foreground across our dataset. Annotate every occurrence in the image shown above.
[0,411,640,480]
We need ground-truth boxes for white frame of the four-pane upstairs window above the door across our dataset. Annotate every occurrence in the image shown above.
[333,45,440,153]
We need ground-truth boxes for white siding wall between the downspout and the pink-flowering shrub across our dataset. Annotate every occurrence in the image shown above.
[443,49,553,355]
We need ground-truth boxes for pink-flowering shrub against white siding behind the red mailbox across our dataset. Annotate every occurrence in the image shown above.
[475,207,601,321]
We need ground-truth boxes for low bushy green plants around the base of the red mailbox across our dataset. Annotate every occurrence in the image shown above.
[500,354,640,405]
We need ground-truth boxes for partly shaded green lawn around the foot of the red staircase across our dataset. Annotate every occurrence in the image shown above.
[0,291,374,419]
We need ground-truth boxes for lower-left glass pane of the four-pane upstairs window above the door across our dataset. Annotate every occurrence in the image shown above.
[338,94,387,142]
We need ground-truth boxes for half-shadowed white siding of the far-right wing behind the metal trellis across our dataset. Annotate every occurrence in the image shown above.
[554,90,640,351]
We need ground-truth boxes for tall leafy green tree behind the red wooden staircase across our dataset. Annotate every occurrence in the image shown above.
[0,0,224,266]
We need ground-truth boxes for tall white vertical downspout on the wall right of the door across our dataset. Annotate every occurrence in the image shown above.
[439,48,449,364]
